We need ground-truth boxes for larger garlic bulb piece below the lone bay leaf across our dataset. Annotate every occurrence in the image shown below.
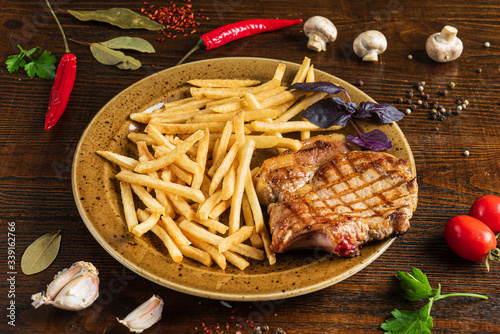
[31,261,99,311]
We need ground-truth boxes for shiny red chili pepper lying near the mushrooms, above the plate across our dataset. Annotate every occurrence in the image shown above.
[177,19,302,65]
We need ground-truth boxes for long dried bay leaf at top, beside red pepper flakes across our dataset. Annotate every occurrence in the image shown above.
[68,8,165,30]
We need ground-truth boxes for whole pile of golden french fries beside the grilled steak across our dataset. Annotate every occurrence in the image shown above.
[96,57,340,270]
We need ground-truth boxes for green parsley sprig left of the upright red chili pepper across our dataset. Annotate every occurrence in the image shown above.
[5,45,57,79]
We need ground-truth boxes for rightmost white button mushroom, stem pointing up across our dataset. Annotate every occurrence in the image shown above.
[425,26,464,63]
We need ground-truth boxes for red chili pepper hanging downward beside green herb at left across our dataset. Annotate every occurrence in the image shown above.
[45,0,76,130]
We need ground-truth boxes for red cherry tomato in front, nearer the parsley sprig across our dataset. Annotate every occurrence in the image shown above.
[444,216,497,262]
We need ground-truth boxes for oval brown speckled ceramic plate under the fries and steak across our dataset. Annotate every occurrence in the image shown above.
[72,58,415,301]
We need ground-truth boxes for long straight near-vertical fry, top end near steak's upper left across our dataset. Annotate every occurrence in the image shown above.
[229,140,255,235]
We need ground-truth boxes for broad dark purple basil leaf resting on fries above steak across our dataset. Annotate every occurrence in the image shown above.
[302,97,358,129]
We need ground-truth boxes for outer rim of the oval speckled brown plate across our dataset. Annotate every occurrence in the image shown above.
[72,57,416,301]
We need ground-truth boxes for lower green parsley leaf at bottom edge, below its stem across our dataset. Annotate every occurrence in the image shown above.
[380,302,433,334]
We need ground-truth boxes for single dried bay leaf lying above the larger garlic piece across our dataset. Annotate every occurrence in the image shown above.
[21,231,61,275]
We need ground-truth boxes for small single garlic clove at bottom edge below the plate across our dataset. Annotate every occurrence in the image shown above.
[116,295,163,333]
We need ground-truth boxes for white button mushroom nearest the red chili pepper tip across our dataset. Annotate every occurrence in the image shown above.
[304,16,337,52]
